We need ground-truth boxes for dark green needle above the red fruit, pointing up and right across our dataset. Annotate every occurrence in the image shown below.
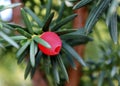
[50,14,77,31]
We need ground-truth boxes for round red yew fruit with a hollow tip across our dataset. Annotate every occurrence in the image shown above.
[38,32,62,56]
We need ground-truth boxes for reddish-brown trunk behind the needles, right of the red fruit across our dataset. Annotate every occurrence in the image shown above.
[65,7,88,86]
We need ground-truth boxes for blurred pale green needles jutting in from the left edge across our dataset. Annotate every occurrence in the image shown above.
[0,3,21,48]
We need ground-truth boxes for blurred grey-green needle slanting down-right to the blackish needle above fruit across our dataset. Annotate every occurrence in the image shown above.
[24,7,43,27]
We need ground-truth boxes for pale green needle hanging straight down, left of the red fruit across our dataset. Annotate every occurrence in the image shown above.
[30,40,35,67]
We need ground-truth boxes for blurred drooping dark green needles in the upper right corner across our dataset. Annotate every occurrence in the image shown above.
[73,0,120,44]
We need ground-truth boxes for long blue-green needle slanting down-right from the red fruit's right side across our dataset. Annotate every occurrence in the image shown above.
[63,41,87,66]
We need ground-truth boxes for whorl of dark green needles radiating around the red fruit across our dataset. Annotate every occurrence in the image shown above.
[9,0,90,83]
